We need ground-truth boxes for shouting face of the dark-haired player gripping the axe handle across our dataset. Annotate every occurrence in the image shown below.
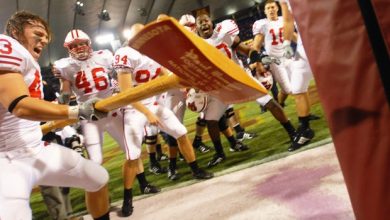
[17,21,49,60]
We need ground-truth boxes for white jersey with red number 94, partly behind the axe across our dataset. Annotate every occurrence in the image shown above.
[114,46,161,104]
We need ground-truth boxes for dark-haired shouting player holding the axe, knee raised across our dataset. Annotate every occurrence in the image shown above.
[0,11,109,220]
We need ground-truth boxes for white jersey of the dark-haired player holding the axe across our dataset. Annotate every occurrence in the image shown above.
[0,34,43,152]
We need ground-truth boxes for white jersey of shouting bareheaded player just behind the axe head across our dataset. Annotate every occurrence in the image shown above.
[205,20,240,60]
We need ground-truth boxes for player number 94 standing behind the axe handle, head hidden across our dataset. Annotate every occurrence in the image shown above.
[114,24,213,215]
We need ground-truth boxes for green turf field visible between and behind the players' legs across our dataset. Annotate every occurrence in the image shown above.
[30,85,330,219]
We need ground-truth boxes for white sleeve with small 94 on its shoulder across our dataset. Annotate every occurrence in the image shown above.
[113,47,142,73]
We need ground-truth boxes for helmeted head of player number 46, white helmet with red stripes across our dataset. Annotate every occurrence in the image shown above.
[64,29,92,60]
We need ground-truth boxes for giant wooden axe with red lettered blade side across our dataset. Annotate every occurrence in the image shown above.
[41,17,267,134]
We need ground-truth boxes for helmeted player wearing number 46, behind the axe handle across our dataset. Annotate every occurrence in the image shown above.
[54,29,160,215]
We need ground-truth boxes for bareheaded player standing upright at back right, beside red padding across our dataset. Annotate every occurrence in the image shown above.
[252,0,314,151]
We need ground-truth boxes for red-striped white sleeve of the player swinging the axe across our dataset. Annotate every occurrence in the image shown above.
[0,35,29,74]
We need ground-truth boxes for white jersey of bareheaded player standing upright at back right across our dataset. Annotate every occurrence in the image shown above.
[252,17,284,57]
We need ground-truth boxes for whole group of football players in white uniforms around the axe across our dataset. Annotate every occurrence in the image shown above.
[0,0,314,219]
